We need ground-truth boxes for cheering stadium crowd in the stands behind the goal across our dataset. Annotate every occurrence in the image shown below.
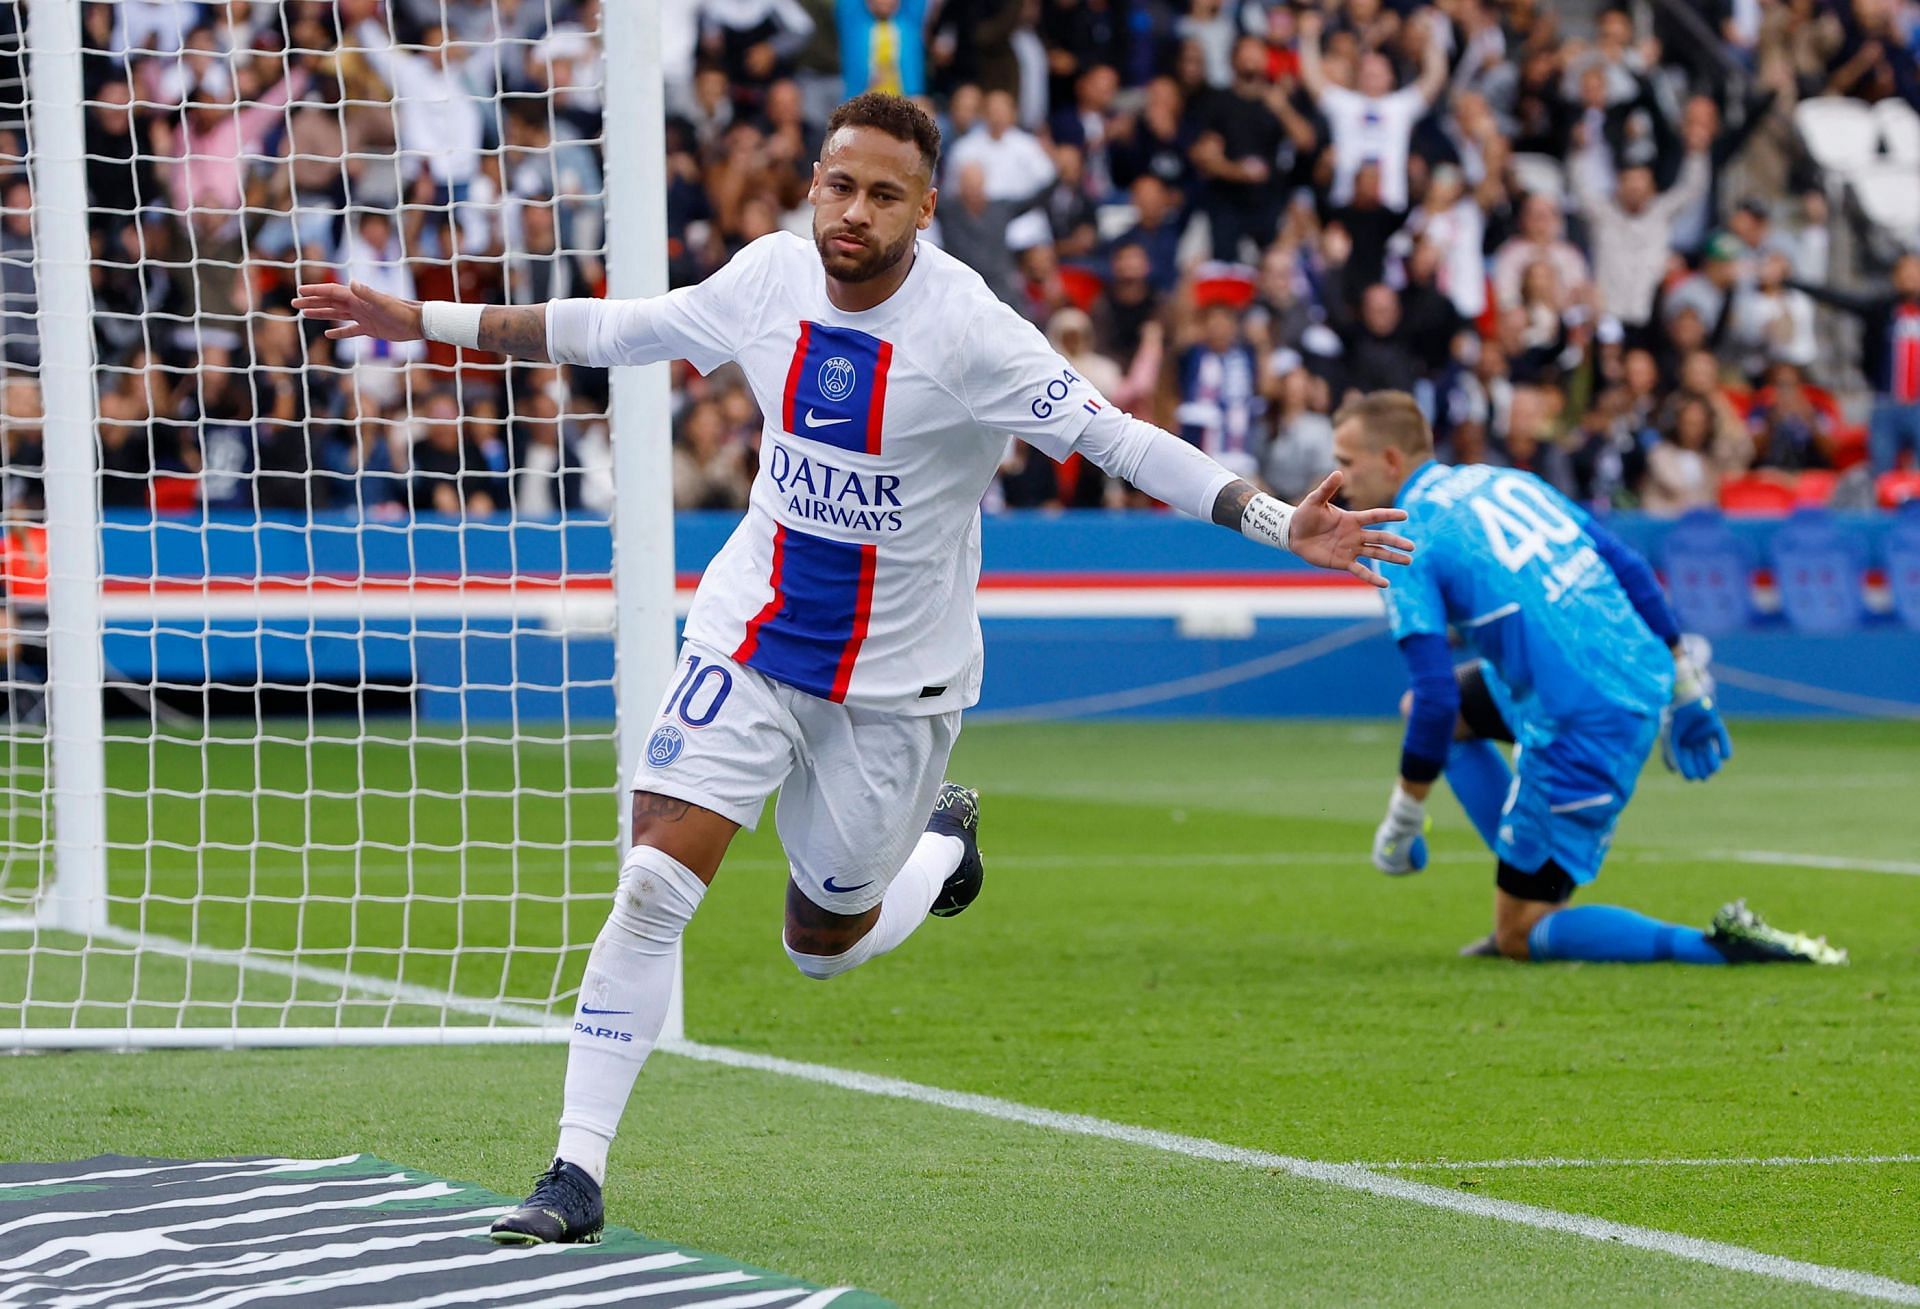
[0,0,1920,514]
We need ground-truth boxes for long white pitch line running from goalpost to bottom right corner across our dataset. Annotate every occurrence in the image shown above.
[659,1040,1920,1305]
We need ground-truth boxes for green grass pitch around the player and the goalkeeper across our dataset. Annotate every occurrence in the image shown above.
[0,722,1920,1305]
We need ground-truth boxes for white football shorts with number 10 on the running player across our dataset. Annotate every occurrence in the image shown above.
[634,641,960,914]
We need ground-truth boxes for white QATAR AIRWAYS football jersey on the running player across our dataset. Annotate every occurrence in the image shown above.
[547,232,1106,714]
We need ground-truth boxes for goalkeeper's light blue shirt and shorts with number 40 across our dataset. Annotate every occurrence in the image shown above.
[1386,463,1674,883]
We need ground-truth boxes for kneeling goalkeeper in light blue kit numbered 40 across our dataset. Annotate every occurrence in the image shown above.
[1334,392,1847,964]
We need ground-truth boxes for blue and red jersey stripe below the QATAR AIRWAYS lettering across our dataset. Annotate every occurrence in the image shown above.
[733,526,879,704]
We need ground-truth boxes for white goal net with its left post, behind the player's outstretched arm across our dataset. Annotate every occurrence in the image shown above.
[0,0,670,1048]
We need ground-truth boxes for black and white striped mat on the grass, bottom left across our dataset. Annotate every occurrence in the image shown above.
[0,1155,887,1309]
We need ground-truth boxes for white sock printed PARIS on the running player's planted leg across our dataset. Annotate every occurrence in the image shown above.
[557,845,707,1182]
